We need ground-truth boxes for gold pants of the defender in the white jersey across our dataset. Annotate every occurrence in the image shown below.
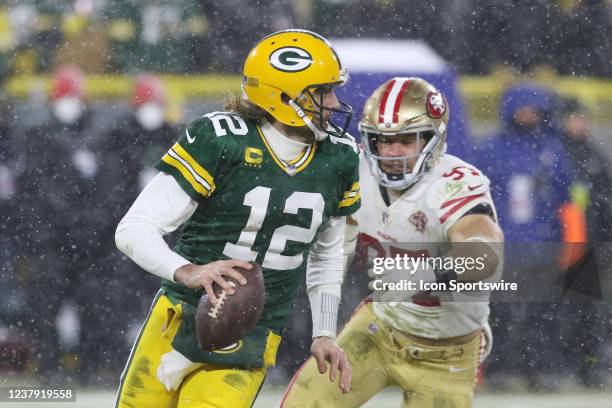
[281,303,483,408]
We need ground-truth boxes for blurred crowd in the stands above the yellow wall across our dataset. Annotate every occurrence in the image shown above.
[0,0,612,77]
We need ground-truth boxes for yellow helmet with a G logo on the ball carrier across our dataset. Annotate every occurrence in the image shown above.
[242,30,352,140]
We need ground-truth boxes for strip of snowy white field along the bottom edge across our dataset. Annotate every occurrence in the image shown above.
[0,388,612,408]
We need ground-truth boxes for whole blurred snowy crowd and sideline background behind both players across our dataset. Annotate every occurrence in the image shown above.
[0,0,612,391]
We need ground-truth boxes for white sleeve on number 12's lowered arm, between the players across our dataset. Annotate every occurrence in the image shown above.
[306,217,346,338]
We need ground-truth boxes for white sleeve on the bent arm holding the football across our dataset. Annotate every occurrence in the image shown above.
[115,173,198,281]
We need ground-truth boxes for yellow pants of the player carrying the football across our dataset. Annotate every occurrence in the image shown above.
[115,294,278,408]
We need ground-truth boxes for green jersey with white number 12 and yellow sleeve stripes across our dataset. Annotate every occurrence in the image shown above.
[157,112,360,330]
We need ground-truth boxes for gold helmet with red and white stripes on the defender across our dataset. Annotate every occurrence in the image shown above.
[359,77,448,190]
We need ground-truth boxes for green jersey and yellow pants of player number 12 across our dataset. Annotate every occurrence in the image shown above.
[119,112,360,408]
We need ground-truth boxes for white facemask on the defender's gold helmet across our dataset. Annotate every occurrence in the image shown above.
[359,124,442,190]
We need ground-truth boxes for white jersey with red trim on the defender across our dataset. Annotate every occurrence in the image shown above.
[352,154,495,339]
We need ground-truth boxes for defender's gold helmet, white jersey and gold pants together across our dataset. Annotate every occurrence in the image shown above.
[281,77,501,408]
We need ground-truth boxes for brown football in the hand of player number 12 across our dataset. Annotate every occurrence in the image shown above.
[196,262,266,351]
